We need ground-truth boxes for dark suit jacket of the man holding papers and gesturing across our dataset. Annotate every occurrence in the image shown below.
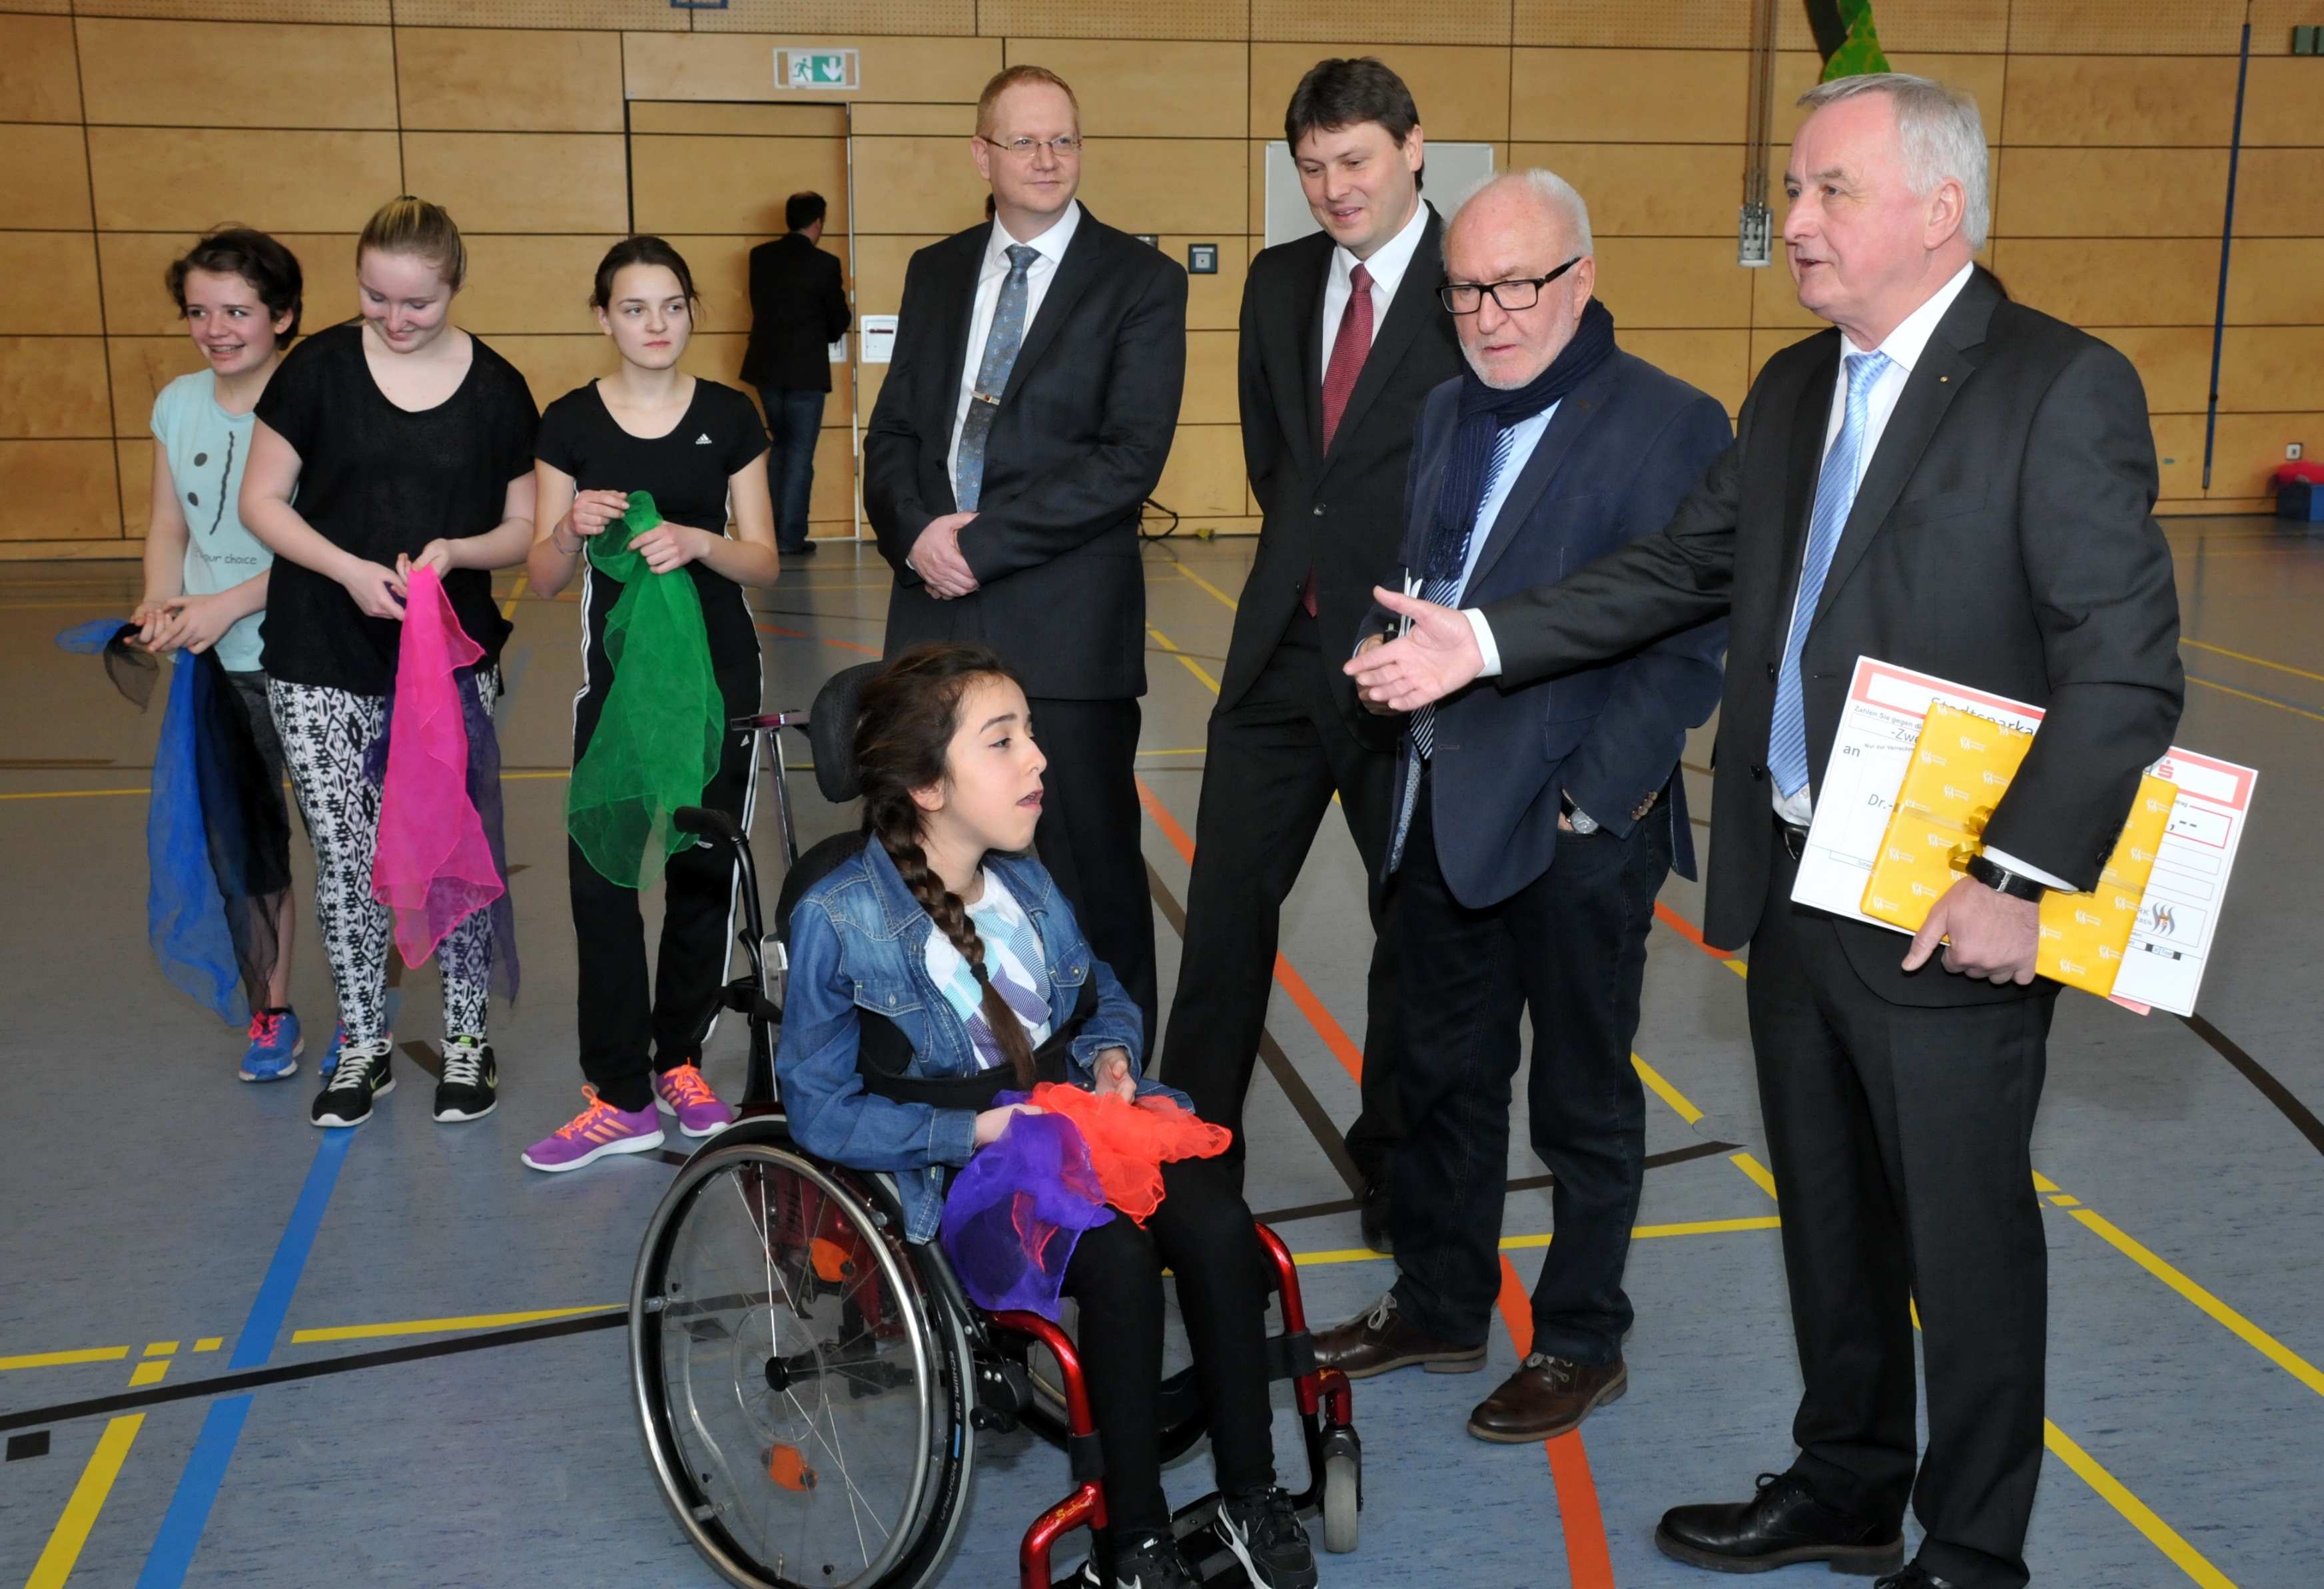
[1485,270,2185,1006]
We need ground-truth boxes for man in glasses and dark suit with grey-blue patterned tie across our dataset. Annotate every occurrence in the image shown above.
[865,65,1185,1041]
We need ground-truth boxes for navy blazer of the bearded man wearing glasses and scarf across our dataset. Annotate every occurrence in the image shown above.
[1367,351,1734,908]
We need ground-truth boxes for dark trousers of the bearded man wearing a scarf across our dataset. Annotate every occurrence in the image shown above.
[1389,776,1671,1364]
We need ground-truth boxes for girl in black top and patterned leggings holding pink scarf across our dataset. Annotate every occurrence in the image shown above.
[242,198,539,1127]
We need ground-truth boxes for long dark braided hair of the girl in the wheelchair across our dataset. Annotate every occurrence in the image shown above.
[855,643,1034,1090]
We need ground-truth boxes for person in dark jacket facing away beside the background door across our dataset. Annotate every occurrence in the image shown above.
[741,193,853,557]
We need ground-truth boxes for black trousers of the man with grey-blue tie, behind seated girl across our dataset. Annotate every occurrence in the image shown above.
[1030,697,1158,1057]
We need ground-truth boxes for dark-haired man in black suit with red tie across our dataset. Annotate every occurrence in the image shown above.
[1162,58,1459,1252]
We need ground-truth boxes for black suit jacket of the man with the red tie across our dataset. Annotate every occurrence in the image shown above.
[1218,206,1459,751]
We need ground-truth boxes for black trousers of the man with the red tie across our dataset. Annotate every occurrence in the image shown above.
[1160,613,1403,1180]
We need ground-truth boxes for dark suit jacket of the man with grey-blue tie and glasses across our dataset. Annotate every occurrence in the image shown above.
[865,209,1185,701]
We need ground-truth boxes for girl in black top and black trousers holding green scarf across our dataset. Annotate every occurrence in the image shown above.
[523,237,779,1171]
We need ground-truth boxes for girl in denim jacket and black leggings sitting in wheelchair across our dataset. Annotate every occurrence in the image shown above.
[776,646,1316,1589]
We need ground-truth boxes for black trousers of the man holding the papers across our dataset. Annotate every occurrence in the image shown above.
[1750,843,2057,1589]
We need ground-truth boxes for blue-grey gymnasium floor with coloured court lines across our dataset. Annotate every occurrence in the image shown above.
[0,518,2324,1589]
